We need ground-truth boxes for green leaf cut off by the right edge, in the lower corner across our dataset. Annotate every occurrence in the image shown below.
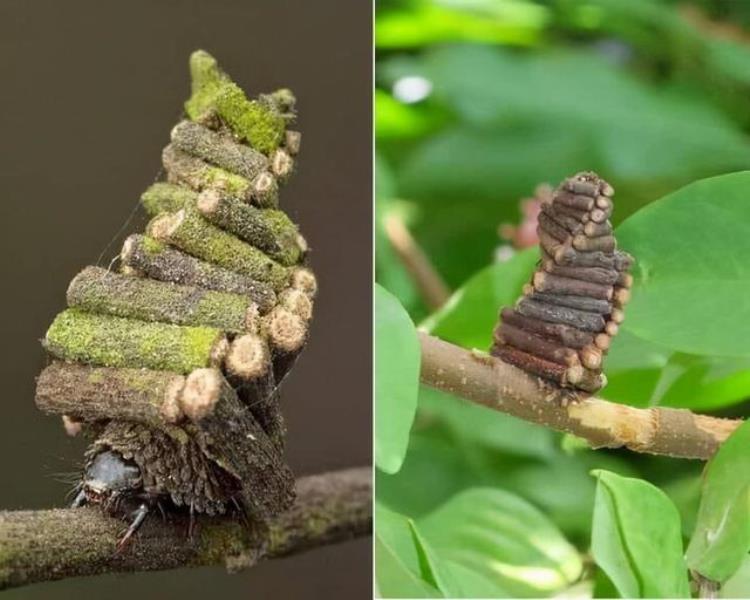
[687,421,750,583]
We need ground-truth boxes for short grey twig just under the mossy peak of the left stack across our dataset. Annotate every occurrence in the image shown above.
[171,121,269,179]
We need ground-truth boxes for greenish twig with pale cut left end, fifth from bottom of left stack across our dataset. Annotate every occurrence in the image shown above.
[148,208,290,291]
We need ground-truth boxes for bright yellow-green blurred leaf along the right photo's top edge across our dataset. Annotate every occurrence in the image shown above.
[375,0,547,48]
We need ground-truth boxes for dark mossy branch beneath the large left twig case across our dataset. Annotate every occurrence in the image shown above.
[0,467,372,590]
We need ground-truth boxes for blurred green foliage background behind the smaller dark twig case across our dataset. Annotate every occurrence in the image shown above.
[375,0,750,597]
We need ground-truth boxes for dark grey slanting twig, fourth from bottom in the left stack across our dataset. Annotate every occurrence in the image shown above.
[120,234,276,314]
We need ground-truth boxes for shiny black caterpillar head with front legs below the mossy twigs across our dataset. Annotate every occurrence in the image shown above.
[72,450,158,549]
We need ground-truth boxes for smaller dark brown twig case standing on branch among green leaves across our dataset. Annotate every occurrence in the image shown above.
[490,172,633,393]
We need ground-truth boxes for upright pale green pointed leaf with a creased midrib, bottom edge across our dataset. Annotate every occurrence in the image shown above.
[591,470,690,598]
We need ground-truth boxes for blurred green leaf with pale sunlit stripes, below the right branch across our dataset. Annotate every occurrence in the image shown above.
[416,488,582,597]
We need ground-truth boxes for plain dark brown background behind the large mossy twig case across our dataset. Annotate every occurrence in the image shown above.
[0,0,372,600]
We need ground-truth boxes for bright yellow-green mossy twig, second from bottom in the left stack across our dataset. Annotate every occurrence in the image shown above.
[44,309,228,373]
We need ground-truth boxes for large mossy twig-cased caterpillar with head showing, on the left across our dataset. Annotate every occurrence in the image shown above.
[31,51,317,545]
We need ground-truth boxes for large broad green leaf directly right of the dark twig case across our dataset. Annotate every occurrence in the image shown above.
[617,171,750,357]
